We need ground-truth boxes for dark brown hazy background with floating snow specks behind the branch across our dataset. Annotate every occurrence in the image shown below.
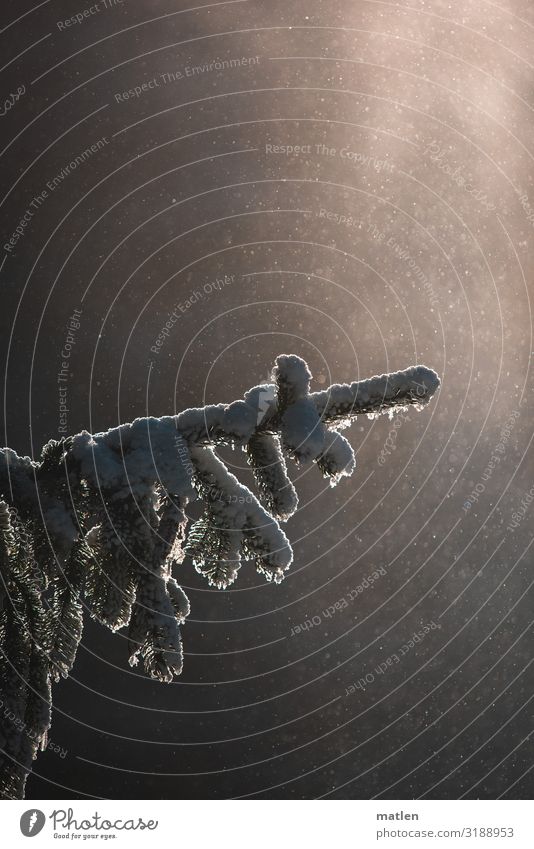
[0,0,534,799]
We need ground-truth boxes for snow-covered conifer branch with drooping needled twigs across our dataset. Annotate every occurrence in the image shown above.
[0,354,439,798]
